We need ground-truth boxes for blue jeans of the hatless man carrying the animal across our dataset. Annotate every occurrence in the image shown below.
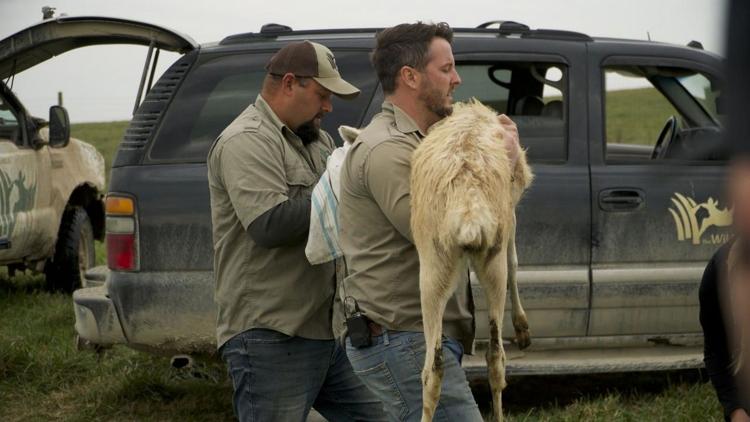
[346,330,482,422]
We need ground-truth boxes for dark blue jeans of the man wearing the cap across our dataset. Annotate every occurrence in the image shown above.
[221,329,385,422]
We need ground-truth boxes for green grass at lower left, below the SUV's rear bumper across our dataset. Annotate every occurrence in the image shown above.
[0,273,232,421]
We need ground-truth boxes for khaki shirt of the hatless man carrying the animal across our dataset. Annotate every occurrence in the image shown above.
[339,101,474,353]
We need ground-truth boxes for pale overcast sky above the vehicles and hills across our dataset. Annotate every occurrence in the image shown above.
[0,0,726,122]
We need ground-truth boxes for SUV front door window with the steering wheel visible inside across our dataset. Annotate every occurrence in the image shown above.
[604,66,725,162]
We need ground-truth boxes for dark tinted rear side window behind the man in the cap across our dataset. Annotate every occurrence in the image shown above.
[149,51,375,162]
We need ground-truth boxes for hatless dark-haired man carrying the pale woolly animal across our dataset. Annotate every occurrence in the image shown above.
[339,23,518,421]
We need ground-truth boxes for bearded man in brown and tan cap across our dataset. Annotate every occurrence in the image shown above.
[207,41,382,421]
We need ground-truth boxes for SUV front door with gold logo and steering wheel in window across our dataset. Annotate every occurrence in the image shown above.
[589,43,731,336]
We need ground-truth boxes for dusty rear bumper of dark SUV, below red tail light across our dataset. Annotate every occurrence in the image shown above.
[73,267,216,355]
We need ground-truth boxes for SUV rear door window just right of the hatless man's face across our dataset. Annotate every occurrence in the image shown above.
[454,62,567,162]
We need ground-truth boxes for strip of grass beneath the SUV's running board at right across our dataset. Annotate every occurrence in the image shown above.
[494,370,722,422]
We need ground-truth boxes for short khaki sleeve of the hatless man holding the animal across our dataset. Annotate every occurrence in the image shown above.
[363,140,414,243]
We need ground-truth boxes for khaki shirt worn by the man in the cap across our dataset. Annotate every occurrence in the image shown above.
[208,95,335,347]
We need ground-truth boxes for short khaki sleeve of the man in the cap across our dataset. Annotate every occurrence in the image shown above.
[218,132,289,230]
